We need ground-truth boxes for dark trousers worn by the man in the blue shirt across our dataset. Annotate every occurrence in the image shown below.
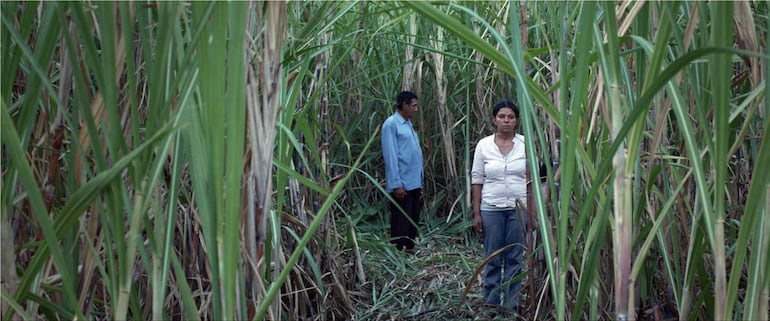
[390,188,422,250]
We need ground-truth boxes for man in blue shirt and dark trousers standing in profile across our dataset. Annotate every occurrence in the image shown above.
[382,91,423,250]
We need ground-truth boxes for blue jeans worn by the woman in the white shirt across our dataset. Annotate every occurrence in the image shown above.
[481,210,524,309]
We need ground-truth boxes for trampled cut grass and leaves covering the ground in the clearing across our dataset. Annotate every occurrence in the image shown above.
[356,213,492,320]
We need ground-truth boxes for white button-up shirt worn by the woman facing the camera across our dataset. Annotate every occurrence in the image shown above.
[471,134,527,210]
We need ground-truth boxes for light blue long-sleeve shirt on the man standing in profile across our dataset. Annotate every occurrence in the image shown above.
[382,112,423,193]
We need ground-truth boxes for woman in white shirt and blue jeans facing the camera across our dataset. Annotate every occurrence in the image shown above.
[471,100,529,309]
